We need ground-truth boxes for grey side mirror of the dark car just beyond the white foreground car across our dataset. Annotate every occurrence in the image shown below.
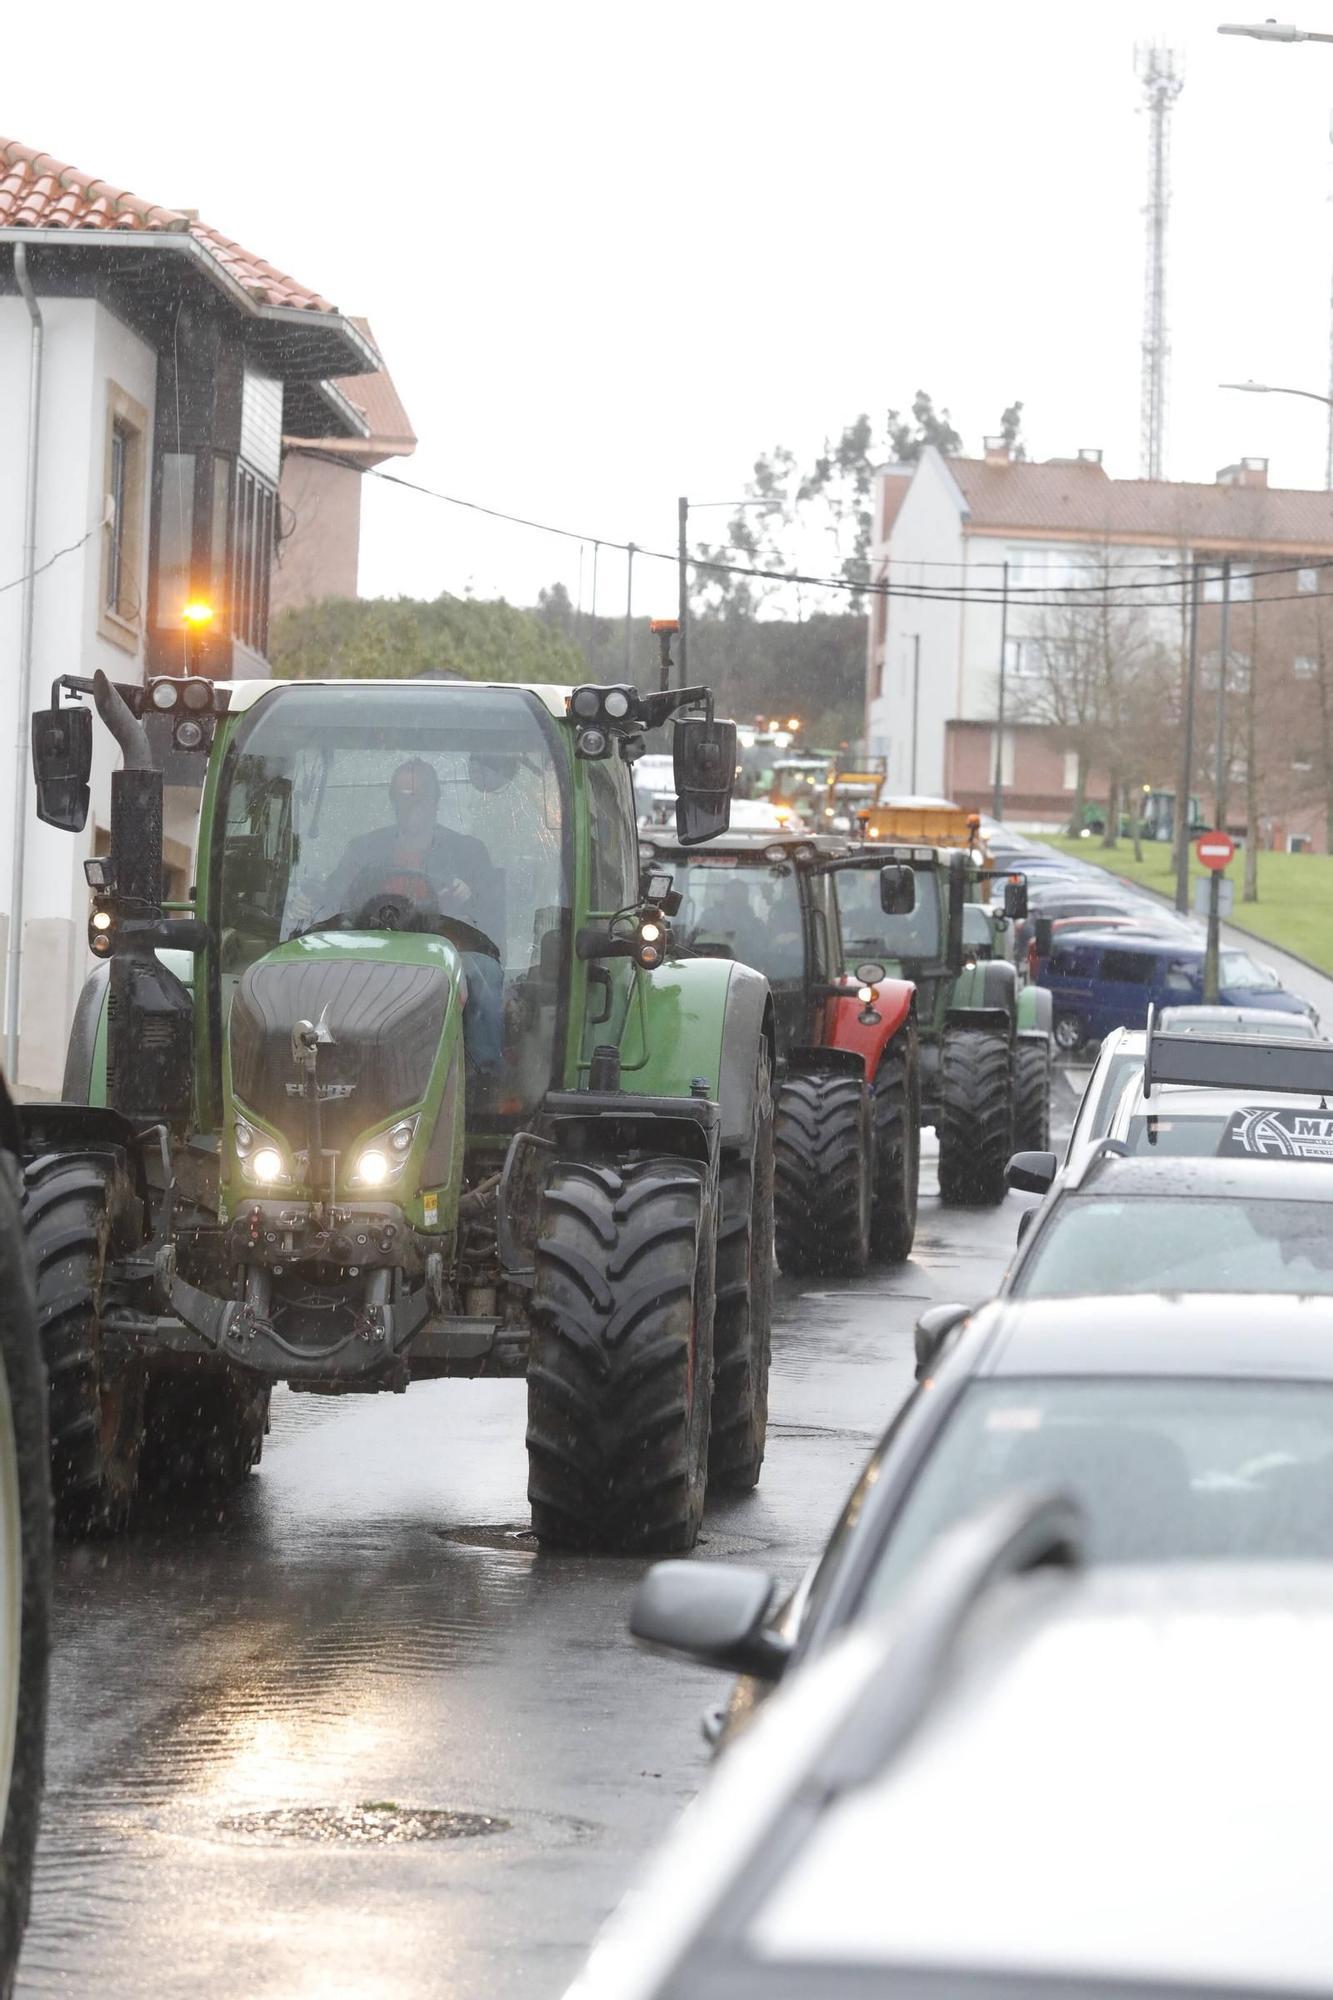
[630,1562,791,1680]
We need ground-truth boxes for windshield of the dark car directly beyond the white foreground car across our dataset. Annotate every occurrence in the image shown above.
[861,1384,1333,1612]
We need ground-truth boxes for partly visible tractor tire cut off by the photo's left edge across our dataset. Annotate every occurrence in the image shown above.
[0,1154,50,2000]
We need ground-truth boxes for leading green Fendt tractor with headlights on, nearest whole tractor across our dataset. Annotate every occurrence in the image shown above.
[24,660,773,1550]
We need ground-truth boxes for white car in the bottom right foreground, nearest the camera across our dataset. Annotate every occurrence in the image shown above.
[568,1504,1333,2000]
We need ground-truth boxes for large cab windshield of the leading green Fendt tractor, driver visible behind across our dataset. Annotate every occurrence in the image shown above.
[212,682,568,1110]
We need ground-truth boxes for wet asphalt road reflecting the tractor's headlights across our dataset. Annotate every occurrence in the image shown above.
[18,1112,1073,2000]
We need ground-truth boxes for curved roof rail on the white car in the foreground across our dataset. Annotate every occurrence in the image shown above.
[811,1490,1087,1792]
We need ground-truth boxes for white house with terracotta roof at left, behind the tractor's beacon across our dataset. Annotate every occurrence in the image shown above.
[0,138,394,1096]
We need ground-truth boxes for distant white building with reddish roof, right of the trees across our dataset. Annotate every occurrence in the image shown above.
[867,440,1333,824]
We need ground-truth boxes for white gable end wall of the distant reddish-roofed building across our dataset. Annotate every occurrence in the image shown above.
[867,450,965,792]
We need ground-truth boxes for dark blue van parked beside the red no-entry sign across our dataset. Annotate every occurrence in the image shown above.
[1037,930,1315,1054]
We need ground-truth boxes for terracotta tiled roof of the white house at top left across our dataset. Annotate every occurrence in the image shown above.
[0,138,336,312]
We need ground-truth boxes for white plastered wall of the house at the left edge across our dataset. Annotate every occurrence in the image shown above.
[0,292,156,1096]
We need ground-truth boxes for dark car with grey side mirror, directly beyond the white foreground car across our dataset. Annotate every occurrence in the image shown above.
[630,1280,1333,1736]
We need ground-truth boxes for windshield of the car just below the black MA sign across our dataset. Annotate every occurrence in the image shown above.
[1013,1186,1333,1298]
